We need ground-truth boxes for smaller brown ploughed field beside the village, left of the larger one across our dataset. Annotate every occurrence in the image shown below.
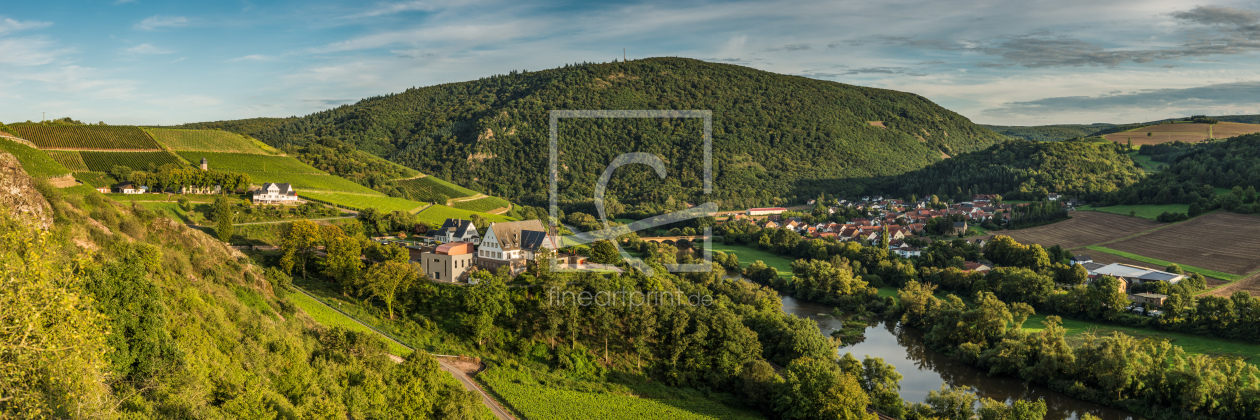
[994,212,1162,249]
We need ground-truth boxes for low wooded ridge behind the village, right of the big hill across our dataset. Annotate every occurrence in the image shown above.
[868,140,1143,199]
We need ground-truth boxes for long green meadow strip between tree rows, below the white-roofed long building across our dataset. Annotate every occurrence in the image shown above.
[1024,314,1260,366]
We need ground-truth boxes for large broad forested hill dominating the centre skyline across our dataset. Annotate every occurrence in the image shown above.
[196,58,1000,207]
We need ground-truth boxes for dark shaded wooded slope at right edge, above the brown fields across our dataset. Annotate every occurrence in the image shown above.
[1104,134,1260,210]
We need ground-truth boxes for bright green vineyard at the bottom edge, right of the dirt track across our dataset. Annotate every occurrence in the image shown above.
[479,367,764,420]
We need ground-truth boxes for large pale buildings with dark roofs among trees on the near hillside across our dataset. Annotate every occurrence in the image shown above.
[374,218,574,283]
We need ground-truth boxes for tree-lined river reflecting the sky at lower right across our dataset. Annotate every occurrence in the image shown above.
[766,287,1145,420]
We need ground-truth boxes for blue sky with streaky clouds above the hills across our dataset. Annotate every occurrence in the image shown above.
[0,0,1260,125]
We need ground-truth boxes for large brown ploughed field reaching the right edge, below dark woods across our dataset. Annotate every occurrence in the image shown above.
[1106,212,1260,275]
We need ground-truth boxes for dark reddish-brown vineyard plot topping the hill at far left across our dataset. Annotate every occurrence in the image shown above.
[9,124,161,150]
